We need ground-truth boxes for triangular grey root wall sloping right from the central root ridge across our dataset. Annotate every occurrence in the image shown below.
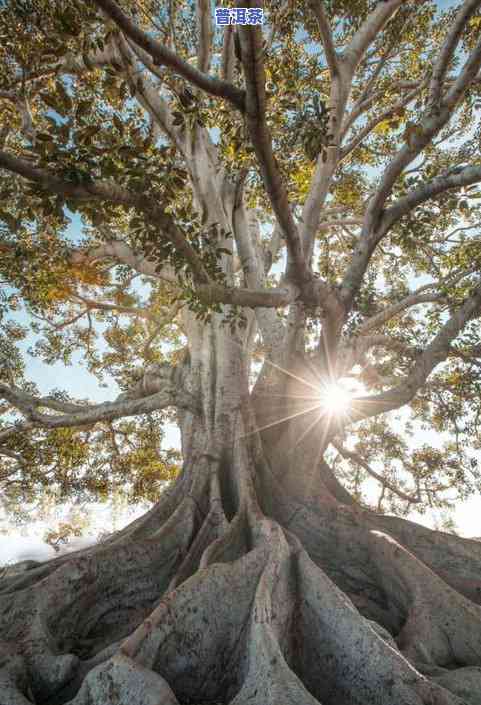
[288,552,458,705]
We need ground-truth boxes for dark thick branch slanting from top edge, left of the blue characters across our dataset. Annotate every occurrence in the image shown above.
[95,0,244,111]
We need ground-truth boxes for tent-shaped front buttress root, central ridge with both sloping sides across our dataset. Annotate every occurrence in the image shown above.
[71,520,470,705]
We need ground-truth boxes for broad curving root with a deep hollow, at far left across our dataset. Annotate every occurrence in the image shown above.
[0,492,199,700]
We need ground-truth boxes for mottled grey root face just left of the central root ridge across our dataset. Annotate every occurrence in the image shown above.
[118,548,266,701]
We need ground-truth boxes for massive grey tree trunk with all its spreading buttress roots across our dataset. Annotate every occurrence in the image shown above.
[0,316,481,705]
